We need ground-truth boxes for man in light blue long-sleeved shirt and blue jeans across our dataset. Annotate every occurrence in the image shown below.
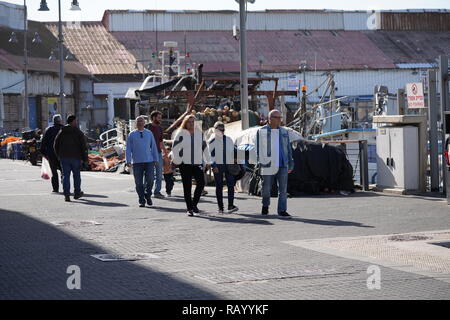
[126,117,159,208]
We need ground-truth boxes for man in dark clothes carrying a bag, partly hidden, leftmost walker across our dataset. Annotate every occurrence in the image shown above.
[41,114,63,193]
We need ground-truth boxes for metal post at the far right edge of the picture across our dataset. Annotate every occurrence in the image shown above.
[439,56,449,194]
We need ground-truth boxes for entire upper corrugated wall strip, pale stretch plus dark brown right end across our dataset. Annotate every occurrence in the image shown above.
[106,10,450,31]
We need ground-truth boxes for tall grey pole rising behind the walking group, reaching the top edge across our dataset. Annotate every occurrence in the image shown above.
[239,0,249,130]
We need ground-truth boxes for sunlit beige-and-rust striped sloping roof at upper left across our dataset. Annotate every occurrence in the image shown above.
[47,22,140,74]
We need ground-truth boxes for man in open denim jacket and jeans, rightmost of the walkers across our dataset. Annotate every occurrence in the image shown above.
[256,109,294,219]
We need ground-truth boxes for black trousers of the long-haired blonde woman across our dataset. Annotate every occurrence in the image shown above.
[180,164,205,210]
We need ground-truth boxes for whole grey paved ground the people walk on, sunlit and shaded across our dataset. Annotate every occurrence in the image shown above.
[0,160,450,299]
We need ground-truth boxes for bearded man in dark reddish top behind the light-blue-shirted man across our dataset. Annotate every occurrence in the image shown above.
[145,110,167,199]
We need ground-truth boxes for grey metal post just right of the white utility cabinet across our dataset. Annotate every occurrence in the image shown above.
[428,70,439,192]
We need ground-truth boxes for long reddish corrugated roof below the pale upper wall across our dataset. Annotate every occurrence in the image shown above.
[112,31,396,72]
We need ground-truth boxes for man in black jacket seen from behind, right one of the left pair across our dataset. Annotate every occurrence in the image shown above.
[54,115,87,202]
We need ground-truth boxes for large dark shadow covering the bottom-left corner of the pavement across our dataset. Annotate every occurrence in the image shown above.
[0,210,219,300]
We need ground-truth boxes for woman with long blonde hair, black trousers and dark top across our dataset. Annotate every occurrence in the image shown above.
[172,115,206,216]
